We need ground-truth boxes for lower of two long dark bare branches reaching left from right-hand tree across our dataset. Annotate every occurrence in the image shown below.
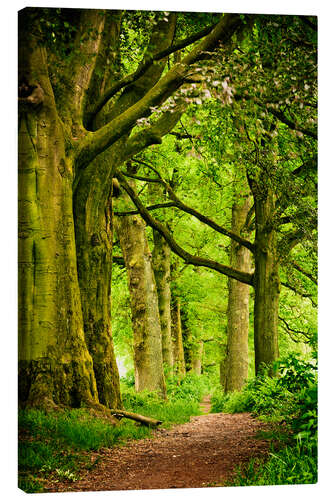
[116,171,253,286]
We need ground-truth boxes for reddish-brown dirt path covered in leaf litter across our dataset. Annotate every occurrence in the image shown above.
[44,396,270,492]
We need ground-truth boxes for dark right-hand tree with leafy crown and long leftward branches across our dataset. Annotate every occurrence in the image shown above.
[117,10,317,373]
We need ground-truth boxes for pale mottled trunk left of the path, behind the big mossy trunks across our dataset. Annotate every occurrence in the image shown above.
[115,186,166,397]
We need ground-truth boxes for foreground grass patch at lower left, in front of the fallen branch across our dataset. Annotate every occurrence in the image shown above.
[18,409,150,493]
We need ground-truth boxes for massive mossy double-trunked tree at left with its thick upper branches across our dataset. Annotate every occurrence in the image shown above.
[19,8,242,406]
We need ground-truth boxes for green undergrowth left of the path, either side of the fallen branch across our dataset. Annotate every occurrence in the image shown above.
[18,375,209,493]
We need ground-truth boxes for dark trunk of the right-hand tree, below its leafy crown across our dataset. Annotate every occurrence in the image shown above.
[252,183,280,374]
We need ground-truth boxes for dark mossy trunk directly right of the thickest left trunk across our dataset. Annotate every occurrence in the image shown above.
[74,151,122,408]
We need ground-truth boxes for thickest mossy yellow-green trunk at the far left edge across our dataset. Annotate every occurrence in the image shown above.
[18,21,98,406]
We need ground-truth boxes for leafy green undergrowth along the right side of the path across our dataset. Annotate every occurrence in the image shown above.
[211,354,317,486]
